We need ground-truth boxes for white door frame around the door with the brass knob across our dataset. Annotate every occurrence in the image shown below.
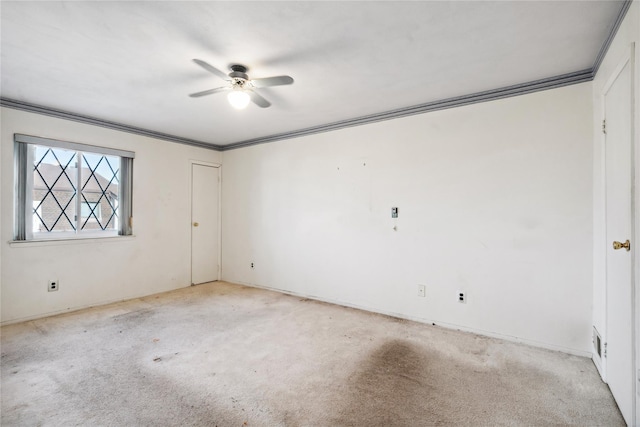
[593,43,640,425]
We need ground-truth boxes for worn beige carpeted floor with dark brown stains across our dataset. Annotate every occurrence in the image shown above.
[0,282,624,427]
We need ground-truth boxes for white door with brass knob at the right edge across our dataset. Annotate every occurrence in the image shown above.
[604,55,636,425]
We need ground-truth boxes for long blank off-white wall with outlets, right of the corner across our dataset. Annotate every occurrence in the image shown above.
[222,83,593,354]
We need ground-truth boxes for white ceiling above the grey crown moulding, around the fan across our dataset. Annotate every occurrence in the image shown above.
[0,1,623,149]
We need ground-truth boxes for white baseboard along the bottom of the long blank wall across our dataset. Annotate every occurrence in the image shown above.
[228,279,592,358]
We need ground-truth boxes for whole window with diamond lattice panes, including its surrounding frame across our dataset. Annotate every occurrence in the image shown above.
[14,134,134,240]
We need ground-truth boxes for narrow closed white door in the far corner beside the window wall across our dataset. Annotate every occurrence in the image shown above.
[191,163,220,285]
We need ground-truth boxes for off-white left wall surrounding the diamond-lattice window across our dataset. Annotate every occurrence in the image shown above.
[0,108,221,323]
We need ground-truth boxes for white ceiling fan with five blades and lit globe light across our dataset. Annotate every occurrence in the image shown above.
[189,59,293,110]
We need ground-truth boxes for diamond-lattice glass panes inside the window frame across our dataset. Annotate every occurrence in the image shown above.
[32,146,120,232]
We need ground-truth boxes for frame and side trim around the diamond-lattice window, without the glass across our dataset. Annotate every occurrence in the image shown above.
[14,133,135,241]
